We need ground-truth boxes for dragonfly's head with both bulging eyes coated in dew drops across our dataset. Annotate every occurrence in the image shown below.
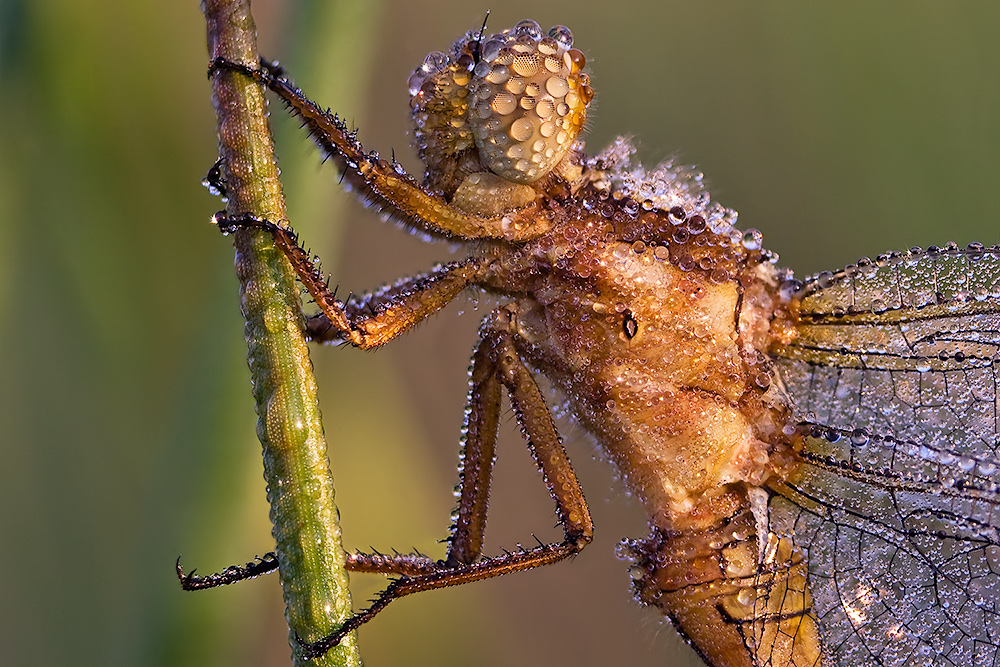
[408,20,594,196]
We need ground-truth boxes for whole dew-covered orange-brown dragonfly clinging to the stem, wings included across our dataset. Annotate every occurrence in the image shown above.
[188,15,1000,666]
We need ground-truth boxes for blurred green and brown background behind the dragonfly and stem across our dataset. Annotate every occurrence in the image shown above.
[0,0,1000,667]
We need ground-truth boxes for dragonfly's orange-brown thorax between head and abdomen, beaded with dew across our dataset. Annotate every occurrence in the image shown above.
[480,177,786,527]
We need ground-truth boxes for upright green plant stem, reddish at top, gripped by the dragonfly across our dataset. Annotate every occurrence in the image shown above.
[203,0,360,666]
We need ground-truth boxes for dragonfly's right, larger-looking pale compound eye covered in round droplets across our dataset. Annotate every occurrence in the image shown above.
[469,21,593,184]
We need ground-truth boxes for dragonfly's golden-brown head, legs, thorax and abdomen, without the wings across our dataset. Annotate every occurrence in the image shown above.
[193,21,997,667]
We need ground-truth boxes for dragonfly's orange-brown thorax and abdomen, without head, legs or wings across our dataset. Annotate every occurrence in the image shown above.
[484,175,819,667]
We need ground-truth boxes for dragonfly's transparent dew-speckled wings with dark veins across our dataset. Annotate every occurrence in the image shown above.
[771,245,1000,667]
